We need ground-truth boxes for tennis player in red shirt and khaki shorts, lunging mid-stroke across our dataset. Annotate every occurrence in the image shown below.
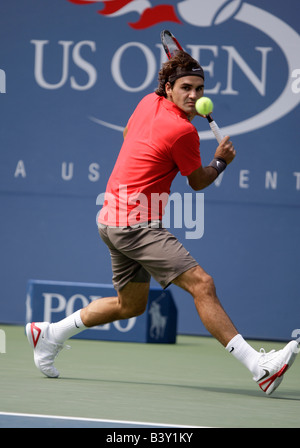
[26,52,298,394]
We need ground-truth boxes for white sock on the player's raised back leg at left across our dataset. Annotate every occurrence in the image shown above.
[49,310,87,344]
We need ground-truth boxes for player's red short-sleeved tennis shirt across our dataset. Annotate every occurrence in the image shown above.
[98,93,201,227]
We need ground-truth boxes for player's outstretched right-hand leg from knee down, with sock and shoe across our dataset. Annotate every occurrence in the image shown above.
[173,266,299,395]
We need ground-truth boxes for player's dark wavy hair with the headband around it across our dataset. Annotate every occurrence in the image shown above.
[155,51,204,97]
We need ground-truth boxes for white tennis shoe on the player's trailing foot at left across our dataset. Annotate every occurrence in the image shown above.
[26,322,64,378]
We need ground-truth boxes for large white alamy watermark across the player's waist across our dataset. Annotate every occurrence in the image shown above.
[96,185,204,239]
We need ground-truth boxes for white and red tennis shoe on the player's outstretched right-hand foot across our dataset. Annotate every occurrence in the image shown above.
[253,341,299,395]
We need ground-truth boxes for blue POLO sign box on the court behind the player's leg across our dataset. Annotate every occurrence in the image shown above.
[26,280,177,344]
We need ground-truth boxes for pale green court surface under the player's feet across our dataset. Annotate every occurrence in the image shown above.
[0,325,300,428]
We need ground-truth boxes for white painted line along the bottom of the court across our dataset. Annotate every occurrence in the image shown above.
[0,412,209,428]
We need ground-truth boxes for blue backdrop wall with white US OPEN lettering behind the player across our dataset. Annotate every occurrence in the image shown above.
[0,0,300,340]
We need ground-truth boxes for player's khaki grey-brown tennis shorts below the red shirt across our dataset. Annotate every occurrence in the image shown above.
[99,223,198,290]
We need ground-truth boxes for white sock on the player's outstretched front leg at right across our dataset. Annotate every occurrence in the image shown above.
[226,334,261,378]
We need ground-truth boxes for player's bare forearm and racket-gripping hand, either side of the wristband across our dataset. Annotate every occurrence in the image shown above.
[187,136,236,191]
